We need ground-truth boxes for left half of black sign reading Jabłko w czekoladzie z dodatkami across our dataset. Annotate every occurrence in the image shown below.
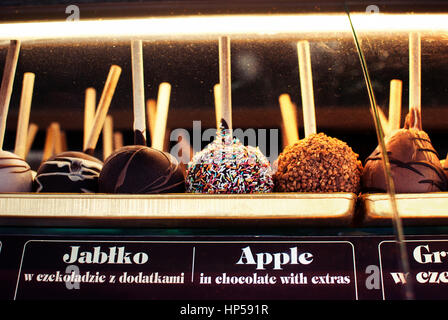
[14,240,192,299]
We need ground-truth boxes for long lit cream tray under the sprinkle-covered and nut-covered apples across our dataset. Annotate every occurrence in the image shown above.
[0,193,357,227]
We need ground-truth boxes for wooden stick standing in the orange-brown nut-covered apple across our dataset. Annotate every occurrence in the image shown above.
[297,40,316,137]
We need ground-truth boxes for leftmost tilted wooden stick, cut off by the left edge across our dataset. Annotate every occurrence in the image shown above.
[0,40,20,150]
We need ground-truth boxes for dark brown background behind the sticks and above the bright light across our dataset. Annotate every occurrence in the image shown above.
[0,1,448,170]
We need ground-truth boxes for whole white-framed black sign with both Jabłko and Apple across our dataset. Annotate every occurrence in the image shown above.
[14,240,358,300]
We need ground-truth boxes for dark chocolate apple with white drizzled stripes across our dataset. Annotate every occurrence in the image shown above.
[34,151,103,193]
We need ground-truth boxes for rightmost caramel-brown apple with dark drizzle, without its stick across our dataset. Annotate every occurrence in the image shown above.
[362,111,448,193]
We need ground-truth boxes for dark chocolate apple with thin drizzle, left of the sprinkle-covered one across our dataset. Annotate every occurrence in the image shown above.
[99,145,185,194]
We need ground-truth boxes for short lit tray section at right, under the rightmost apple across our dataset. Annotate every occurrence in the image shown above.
[359,192,448,226]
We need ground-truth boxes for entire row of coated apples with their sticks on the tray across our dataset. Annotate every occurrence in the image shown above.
[0,37,448,194]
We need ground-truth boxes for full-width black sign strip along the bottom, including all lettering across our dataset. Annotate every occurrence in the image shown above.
[0,232,448,301]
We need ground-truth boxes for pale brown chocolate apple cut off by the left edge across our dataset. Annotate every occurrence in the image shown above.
[0,150,33,192]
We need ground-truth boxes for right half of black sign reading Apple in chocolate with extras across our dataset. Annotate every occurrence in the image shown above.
[195,241,358,300]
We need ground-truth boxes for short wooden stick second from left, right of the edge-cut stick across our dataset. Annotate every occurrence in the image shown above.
[14,72,35,159]
